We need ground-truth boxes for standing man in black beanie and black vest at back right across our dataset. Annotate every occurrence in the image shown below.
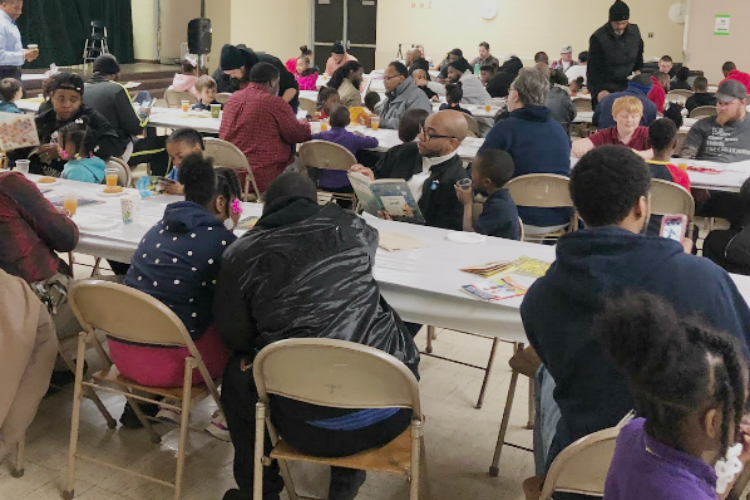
[587,0,643,108]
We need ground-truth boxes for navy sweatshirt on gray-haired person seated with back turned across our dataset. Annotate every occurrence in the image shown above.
[479,106,573,227]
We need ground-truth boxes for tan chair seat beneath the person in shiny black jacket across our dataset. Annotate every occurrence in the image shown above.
[271,429,411,476]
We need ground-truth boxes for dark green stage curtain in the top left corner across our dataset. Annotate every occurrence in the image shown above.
[18,0,133,68]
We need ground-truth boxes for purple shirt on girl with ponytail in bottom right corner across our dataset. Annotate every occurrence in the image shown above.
[604,418,716,500]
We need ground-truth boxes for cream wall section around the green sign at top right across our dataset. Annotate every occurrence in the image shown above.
[687,0,750,84]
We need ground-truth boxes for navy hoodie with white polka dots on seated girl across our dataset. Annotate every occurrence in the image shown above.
[125,201,237,340]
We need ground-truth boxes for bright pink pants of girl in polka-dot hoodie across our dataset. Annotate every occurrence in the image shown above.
[109,326,229,388]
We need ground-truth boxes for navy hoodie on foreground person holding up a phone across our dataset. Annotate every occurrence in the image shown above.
[521,226,750,460]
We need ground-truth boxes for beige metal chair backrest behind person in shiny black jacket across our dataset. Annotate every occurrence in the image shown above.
[253,338,422,417]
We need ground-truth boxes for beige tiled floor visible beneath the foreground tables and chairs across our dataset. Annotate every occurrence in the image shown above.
[0,260,533,500]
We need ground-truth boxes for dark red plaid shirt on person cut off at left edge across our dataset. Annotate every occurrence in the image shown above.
[0,172,78,283]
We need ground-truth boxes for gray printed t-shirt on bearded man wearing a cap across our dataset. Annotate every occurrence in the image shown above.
[680,114,750,163]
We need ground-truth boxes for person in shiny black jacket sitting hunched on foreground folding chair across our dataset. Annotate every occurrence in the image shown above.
[214,173,420,500]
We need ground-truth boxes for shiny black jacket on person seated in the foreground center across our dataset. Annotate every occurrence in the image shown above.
[214,198,419,375]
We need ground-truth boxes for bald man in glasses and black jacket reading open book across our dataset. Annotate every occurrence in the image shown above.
[351,110,469,231]
